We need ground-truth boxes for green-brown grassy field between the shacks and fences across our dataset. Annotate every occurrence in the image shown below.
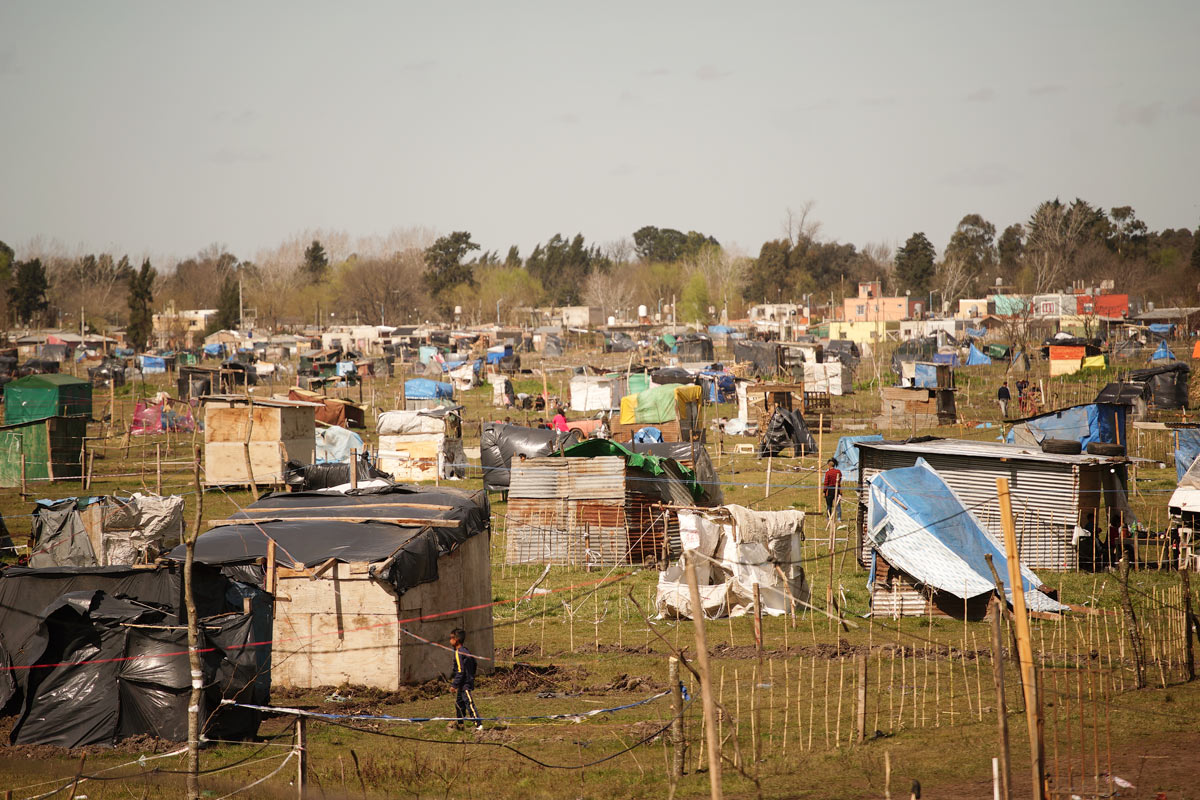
[0,356,1200,799]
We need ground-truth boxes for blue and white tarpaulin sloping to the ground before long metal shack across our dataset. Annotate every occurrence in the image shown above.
[866,458,1064,612]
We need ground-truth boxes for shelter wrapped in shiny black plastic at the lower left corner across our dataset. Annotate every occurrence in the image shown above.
[0,566,271,747]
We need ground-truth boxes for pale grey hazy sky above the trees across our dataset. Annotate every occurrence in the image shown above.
[0,0,1200,266]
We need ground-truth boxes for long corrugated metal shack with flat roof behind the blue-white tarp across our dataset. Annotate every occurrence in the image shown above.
[857,439,1133,570]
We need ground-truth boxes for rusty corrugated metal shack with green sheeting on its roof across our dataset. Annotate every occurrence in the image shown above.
[505,439,712,566]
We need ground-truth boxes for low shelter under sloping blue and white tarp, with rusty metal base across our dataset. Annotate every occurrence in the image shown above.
[866,458,1066,618]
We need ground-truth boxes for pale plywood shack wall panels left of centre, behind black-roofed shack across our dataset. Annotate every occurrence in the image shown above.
[204,403,316,486]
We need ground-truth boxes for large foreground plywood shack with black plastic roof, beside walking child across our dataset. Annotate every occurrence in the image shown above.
[170,486,492,691]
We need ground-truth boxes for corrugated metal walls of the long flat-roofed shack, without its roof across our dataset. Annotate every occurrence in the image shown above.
[859,447,1084,570]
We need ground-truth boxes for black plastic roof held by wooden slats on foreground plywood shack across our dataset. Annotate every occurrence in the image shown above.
[167,486,491,595]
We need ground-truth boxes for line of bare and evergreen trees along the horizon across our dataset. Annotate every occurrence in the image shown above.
[0,198,1200,347]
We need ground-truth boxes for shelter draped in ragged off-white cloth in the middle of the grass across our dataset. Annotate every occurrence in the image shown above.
[654,505,809,619]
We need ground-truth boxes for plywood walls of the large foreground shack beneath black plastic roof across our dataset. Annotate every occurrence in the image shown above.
[271,533,494,691]
